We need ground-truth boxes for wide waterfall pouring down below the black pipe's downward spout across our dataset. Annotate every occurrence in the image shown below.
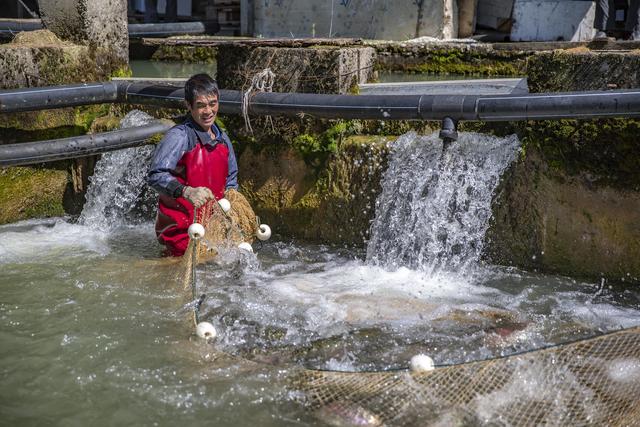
[367,132,519,272]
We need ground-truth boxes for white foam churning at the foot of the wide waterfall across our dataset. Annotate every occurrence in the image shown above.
[240,261,510,331]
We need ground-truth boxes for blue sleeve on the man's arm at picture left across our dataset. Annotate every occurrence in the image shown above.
[147,127,189,197]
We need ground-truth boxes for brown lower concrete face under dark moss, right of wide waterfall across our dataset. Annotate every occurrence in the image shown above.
[485,147,640,284]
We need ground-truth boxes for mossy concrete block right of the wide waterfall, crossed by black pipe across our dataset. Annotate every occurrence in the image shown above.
[487,48,640,283]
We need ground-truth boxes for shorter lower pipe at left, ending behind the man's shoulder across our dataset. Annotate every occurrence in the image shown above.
[0,120,173,166]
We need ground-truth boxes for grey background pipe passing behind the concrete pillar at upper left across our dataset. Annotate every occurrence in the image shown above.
[0,19,220,39]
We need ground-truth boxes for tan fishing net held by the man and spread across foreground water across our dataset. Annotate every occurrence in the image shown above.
[179,196,640,426]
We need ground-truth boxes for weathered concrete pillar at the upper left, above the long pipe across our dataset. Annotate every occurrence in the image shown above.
[39,0,129,70]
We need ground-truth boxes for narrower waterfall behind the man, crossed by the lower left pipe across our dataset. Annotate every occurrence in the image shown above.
[79,110,156,230]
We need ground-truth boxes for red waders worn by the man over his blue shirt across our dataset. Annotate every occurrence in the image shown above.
[156,142,229,256]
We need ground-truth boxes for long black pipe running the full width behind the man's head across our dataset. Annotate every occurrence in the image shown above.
[0,81,640,122]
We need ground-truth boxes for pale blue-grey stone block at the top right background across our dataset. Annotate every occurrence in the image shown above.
[511,0,596,42]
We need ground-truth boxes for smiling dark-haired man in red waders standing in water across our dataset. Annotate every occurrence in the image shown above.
[147,74,238,256]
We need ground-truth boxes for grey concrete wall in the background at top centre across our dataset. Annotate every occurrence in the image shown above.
[242,0,458,40]
